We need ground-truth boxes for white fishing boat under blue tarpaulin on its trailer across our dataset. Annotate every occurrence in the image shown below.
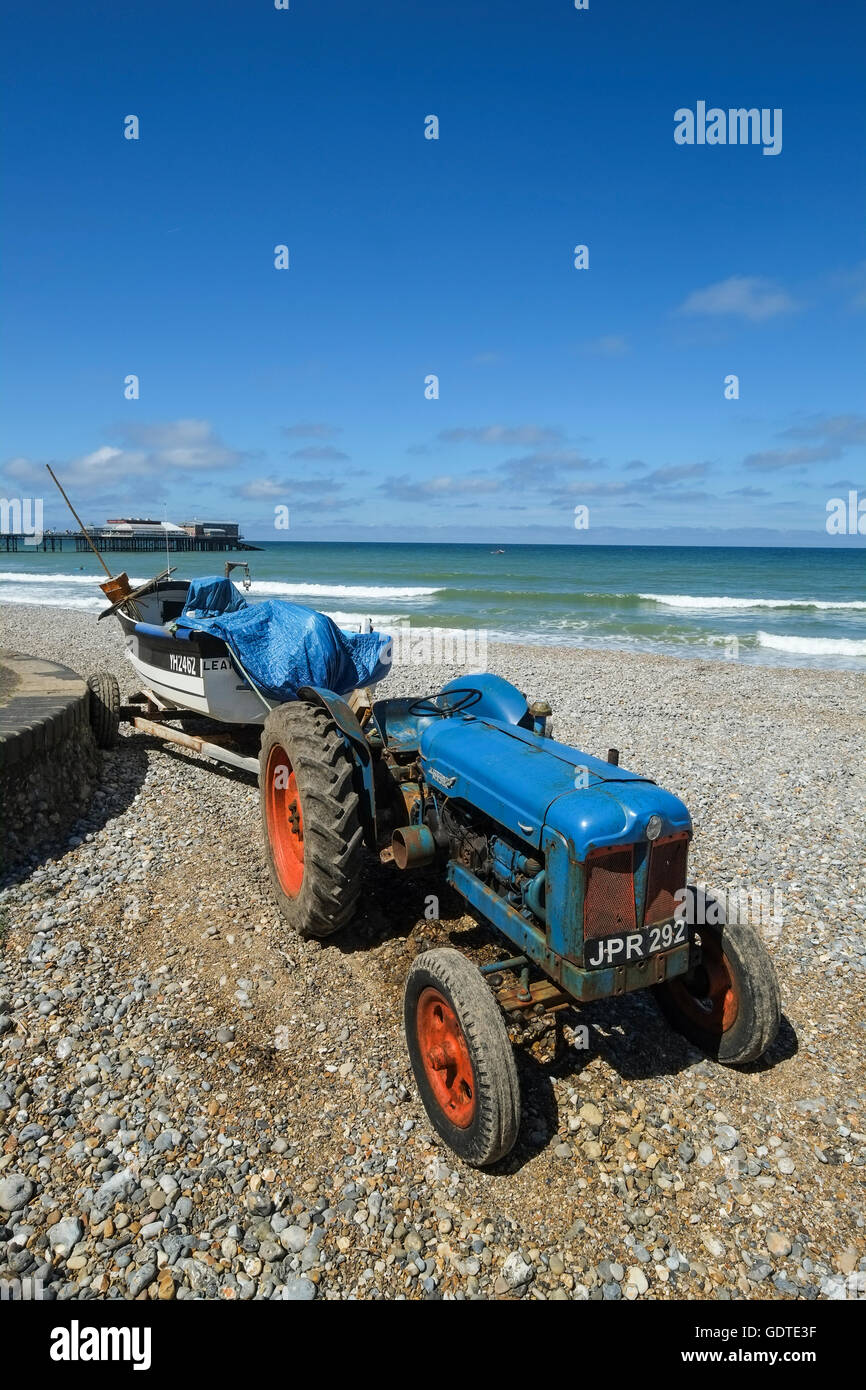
[46,464,392,773]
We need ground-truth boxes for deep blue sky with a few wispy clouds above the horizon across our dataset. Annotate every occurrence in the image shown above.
[0,0,866,543]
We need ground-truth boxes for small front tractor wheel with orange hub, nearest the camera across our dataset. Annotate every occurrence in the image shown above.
[403,948,520,1168]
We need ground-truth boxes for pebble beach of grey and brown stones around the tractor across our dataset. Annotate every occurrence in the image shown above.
[0,605,866,1300]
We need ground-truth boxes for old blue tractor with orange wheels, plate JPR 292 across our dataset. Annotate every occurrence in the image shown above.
[260,674,780,1166]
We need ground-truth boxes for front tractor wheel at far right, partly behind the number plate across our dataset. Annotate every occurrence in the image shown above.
[653,899,781,1066]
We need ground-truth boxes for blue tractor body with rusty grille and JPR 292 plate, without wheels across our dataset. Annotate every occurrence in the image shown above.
[372,676,692,973]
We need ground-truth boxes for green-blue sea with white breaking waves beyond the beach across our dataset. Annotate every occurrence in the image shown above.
[0,541,866,671]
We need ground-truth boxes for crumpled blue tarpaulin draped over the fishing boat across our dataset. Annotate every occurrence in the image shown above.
[177,575,391,702]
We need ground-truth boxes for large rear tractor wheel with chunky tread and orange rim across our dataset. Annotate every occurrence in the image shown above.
[259,701,364,937]
